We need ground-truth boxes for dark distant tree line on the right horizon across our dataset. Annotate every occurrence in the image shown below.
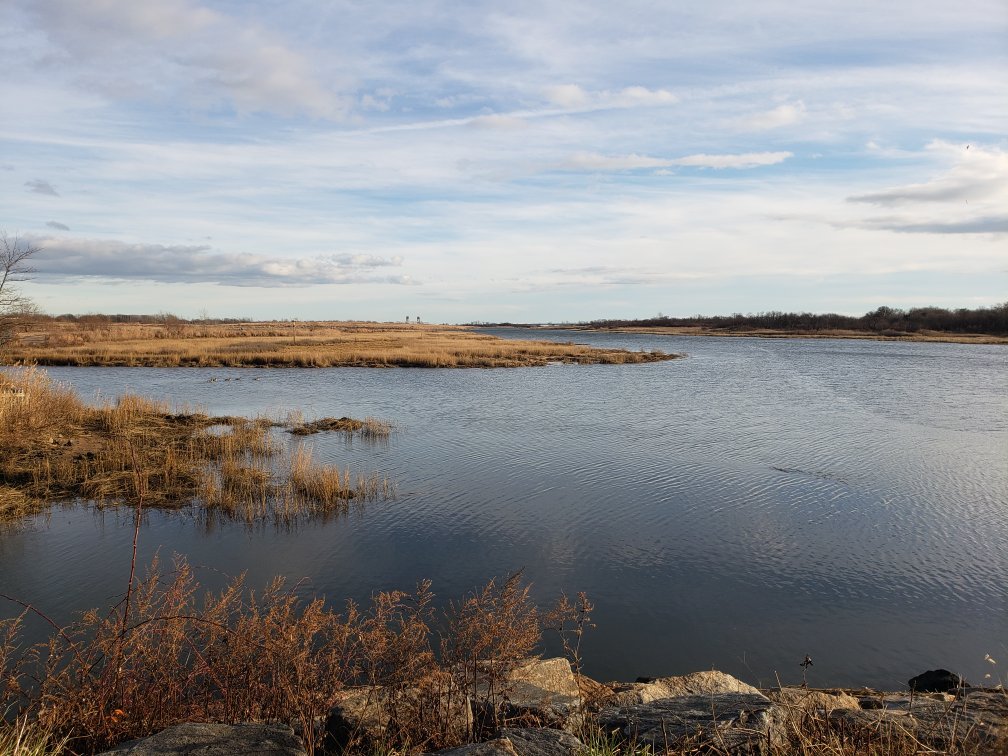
[586,301,1008,336]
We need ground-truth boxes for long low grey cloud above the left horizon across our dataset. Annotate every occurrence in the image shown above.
[34,238,413,286]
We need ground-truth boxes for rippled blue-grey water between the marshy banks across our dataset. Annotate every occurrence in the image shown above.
[0,331,1008,687]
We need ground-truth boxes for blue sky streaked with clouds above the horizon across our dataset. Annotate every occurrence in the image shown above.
[0,0,1008,323]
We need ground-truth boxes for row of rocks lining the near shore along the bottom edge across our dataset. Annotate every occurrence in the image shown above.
[100,658,1008,756]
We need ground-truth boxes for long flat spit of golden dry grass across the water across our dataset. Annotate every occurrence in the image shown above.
[3,322,675,368]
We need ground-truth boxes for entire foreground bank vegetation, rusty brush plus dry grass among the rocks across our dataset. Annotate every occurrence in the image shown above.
[0,559,1008,756]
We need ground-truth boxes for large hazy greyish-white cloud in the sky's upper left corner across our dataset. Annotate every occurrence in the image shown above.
[18,0,348,117]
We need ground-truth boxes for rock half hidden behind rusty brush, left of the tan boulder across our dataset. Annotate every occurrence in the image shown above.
[326,686,473,752]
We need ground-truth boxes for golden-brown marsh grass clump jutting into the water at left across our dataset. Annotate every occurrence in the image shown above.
[0,369,392,522]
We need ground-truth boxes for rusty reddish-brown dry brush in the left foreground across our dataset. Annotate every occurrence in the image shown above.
[0,557,560,753]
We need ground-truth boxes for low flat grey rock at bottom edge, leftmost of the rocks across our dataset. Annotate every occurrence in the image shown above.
[105,722,306,756]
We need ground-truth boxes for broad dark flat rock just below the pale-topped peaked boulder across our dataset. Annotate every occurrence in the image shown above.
[598,697,784,754]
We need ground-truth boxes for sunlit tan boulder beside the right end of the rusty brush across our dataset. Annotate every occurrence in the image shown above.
[477,658,584,730]
